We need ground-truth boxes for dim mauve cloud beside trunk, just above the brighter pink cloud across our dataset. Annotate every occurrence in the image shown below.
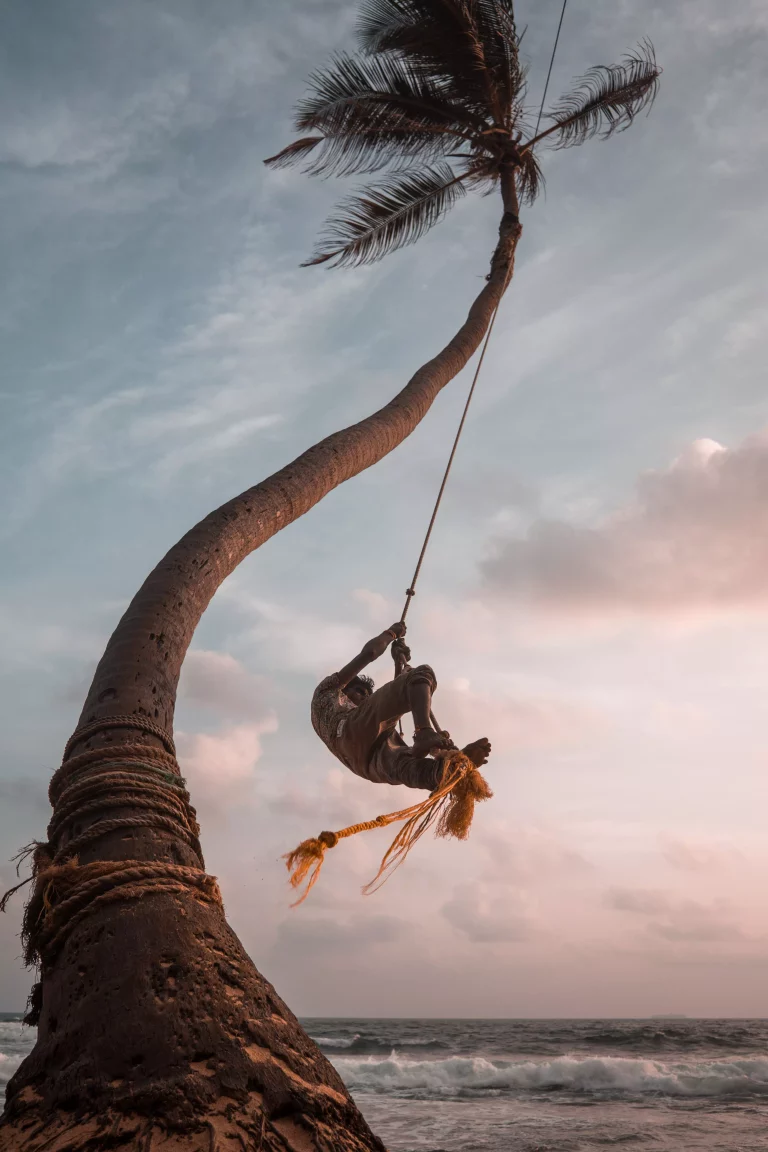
[178,649,271,721]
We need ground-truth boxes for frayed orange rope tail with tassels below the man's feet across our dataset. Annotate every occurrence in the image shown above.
[283,749,493,908]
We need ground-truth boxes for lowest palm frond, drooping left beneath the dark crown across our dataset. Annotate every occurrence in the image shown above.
[304,164,465,267]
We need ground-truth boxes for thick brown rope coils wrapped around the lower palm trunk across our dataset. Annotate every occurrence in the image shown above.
[0,717,221,1009]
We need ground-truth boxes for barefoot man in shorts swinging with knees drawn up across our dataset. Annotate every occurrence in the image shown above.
[312,621,491,791]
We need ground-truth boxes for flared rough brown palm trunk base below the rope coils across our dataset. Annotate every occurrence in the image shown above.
[0,893,383,1152]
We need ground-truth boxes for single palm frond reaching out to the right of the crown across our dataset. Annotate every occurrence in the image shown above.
[539,40,661,147]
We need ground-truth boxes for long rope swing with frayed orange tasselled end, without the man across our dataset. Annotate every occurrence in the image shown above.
[283,0,568,908]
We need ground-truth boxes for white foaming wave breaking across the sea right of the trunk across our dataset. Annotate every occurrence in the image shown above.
[334,1053,768,1099]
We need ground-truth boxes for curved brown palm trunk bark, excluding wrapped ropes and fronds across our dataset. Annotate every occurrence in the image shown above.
[0,200,520,1152]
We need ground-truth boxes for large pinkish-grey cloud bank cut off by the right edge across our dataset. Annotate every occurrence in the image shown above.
[482,431,768,614]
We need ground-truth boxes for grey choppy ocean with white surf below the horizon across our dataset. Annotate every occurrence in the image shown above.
[0,1015,768,1152]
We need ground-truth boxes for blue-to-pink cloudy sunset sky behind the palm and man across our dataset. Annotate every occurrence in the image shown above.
[0,0,768,1016]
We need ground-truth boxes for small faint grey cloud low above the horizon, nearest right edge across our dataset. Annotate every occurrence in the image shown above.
[606,888,745,943]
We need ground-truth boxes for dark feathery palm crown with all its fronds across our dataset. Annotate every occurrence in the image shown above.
[265,0,661,265]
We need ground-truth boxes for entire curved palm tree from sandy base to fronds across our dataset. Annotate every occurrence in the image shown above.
[0,0,659,1152]
